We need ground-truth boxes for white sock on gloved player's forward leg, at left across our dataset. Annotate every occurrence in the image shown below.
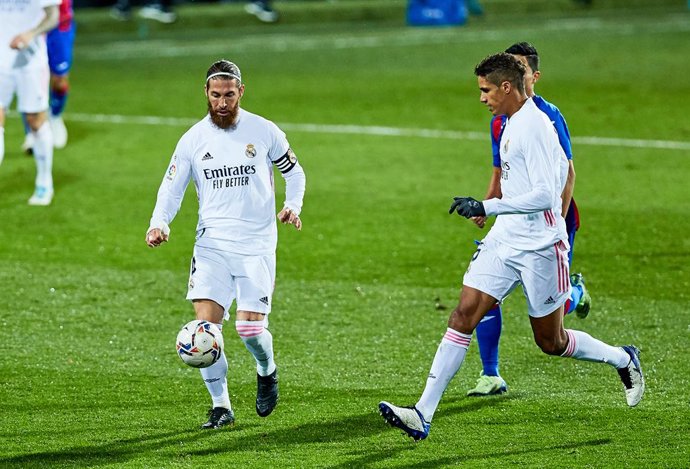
[415,327,472,422]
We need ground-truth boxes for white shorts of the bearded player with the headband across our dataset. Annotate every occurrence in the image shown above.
[187,245,276,319]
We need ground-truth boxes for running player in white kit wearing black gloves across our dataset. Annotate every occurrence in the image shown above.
[379,53,644,440]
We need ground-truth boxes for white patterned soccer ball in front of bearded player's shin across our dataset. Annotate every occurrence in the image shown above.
[177,319,223,368]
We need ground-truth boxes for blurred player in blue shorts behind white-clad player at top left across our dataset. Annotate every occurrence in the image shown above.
[22,0,75,154]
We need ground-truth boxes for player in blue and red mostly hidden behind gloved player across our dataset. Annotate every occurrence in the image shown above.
[467,42,592,396]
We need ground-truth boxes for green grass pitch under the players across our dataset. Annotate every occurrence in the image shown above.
[0,0,690,469]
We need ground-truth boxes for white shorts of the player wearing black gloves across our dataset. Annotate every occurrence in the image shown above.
[463,239,570,318]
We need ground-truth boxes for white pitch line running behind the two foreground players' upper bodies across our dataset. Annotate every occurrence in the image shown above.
[65,113,690,151]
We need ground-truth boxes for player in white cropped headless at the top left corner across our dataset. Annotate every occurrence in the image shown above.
[0,0,60,205]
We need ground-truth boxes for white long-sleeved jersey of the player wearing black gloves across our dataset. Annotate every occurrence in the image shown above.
[484,98,568,251]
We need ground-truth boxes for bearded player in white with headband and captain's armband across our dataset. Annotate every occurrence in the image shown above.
[146,60,306,429]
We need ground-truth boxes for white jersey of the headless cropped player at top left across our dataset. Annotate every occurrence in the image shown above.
[0,0,61,71]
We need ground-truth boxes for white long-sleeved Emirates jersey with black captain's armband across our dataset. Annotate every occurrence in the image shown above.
[150,109,305,255]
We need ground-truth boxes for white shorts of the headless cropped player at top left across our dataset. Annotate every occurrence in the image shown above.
[0,63,50,113]
